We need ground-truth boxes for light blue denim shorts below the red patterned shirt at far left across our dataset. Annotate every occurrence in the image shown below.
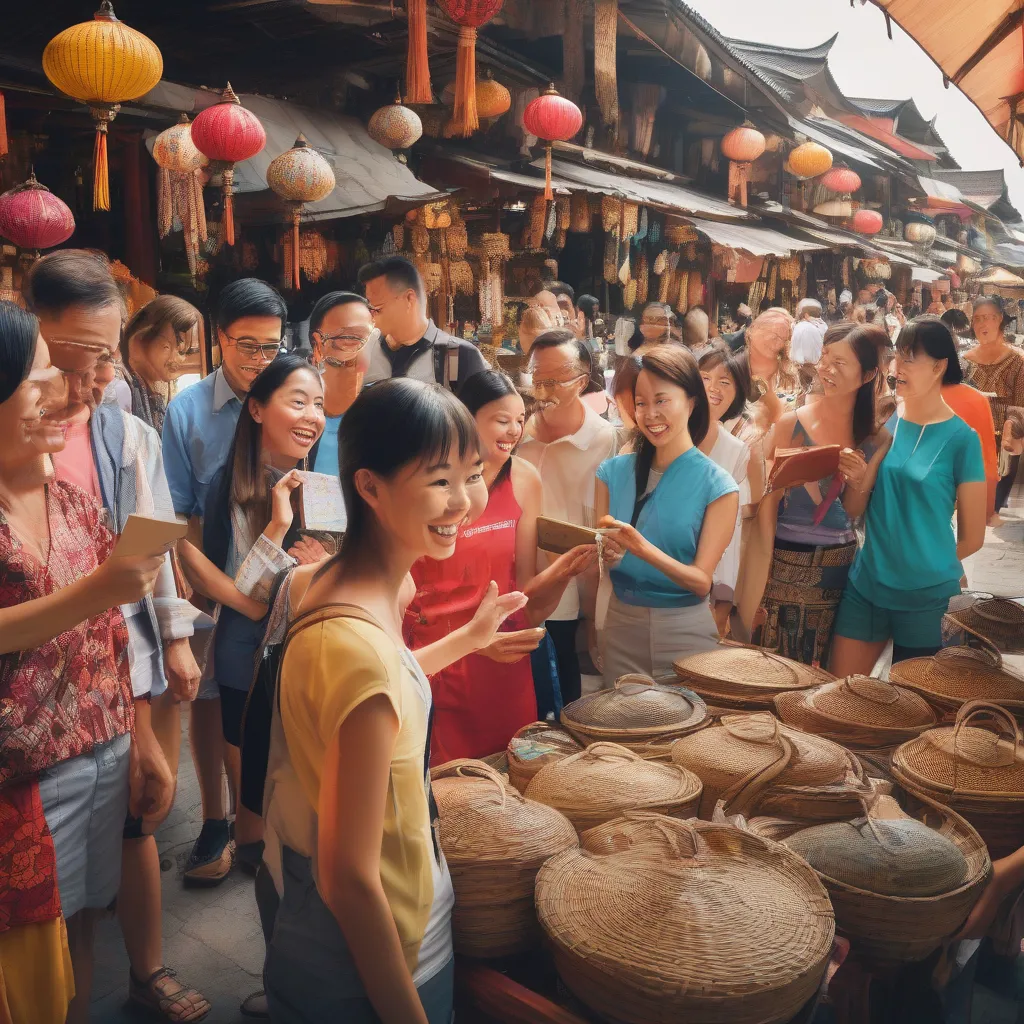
[39,733,131,918]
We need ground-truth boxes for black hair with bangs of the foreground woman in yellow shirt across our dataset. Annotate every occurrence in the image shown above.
[335,377,480,559]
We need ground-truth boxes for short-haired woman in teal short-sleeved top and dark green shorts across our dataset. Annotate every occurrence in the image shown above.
[830,316,986,676]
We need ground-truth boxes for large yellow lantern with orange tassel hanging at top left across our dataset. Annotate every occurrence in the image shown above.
[43,0,164,210]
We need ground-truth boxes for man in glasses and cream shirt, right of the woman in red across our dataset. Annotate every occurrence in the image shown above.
[519,329,615,711]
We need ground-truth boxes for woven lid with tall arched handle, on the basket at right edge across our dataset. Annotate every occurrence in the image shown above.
[893,700,1024,800]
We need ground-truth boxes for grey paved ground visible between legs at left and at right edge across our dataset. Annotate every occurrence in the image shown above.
[92,522,1024,1024]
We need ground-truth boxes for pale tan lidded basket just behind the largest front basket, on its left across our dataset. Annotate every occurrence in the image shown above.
[526,743,700,831]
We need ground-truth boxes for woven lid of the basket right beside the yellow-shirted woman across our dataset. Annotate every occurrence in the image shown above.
[430,759,578,864]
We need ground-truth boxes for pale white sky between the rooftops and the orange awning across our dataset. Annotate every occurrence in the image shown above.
[686,0,1024,213]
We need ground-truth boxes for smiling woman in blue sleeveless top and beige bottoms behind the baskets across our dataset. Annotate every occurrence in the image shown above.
[597,345,739,684]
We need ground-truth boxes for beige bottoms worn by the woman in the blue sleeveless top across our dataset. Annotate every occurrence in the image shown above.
[602,594,719,686]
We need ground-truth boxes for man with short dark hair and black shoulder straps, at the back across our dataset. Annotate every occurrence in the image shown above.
[359,256,487,391]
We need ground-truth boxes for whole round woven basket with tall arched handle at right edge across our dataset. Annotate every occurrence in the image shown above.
[892,700,1024,859]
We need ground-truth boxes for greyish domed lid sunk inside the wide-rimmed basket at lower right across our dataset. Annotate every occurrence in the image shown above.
[783,817,970,897]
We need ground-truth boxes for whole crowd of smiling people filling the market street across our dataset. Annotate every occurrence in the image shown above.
[0,250,1024,1024]
